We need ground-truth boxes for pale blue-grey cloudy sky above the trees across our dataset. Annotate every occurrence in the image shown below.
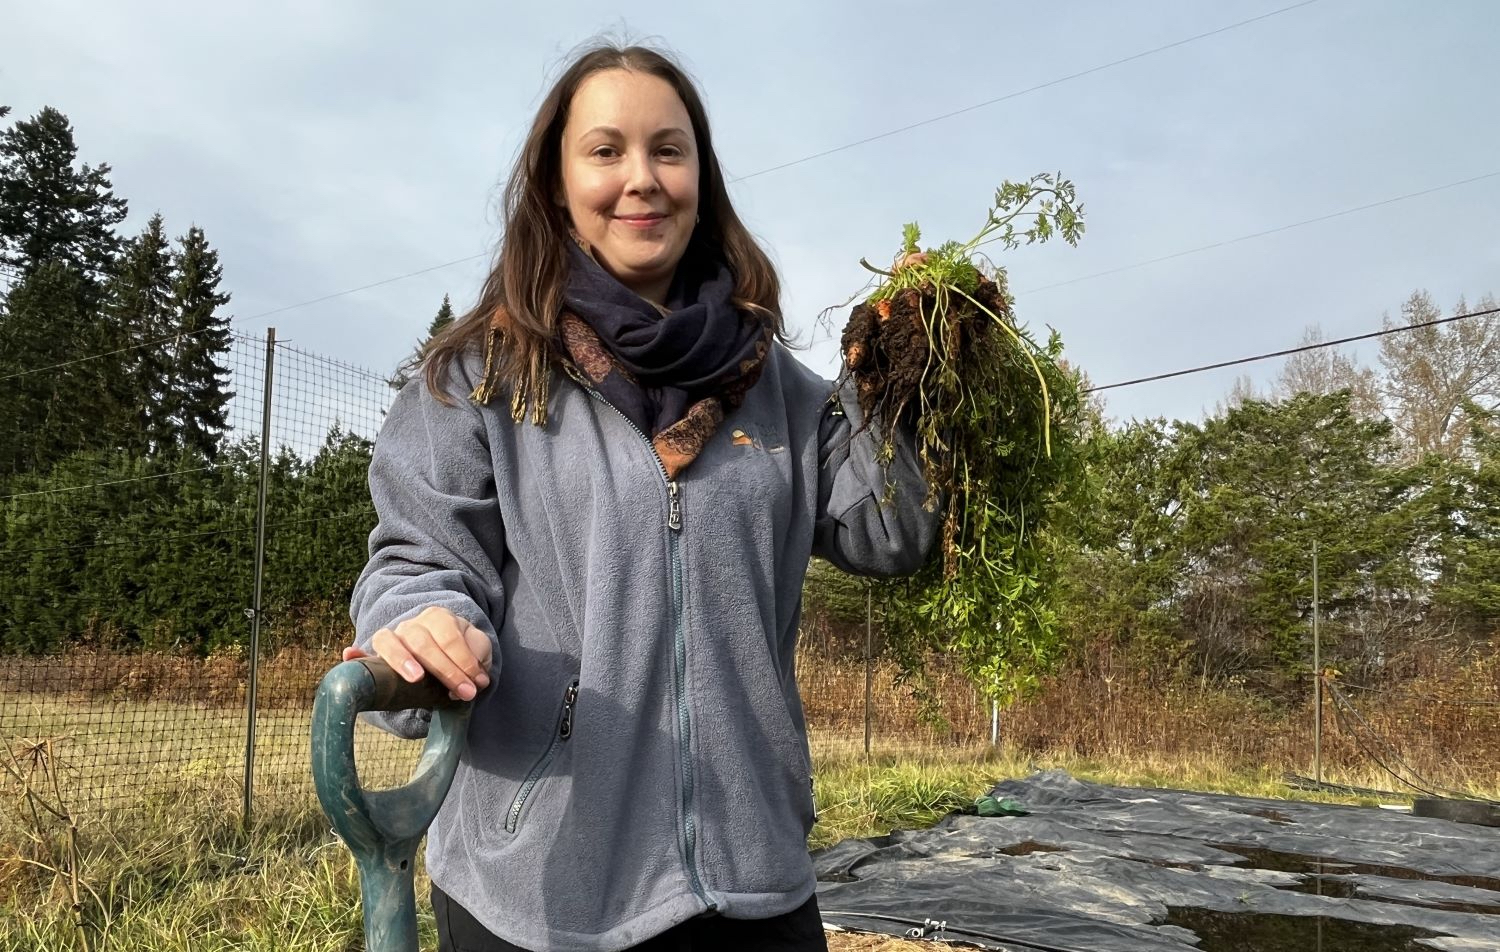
[0,0,1500,421]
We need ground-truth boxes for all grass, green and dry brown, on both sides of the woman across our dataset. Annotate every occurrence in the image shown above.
[0,650,1500,952]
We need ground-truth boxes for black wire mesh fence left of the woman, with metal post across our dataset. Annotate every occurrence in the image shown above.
[0,325,414,817]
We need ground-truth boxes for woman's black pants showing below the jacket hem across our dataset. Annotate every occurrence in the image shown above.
[432,886,828,952]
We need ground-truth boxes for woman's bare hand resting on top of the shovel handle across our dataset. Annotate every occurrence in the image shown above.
[344,606,494,700]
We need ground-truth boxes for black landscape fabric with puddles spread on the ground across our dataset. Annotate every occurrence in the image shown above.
[813,771,1500,952]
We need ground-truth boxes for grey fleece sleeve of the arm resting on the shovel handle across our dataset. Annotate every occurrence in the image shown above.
[350,373,506,738]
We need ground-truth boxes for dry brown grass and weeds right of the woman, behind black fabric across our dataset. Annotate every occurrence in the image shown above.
[798,644,1500,793]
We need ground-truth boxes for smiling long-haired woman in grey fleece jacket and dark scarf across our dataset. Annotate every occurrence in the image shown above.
[345,48,936,952]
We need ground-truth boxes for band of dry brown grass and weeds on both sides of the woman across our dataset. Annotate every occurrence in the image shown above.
[0,648,1500,809]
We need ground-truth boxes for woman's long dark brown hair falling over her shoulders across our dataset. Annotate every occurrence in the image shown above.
[423,43,786,424]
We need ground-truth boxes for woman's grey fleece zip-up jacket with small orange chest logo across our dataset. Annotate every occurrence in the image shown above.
[351,345,938,952]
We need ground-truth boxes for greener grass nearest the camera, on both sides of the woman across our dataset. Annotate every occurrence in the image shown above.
[0,738,1452,952]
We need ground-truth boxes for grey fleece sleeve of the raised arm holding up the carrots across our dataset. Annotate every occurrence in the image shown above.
[813,377,942,577]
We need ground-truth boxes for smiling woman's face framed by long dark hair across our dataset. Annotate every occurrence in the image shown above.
[560,69,698,304]
